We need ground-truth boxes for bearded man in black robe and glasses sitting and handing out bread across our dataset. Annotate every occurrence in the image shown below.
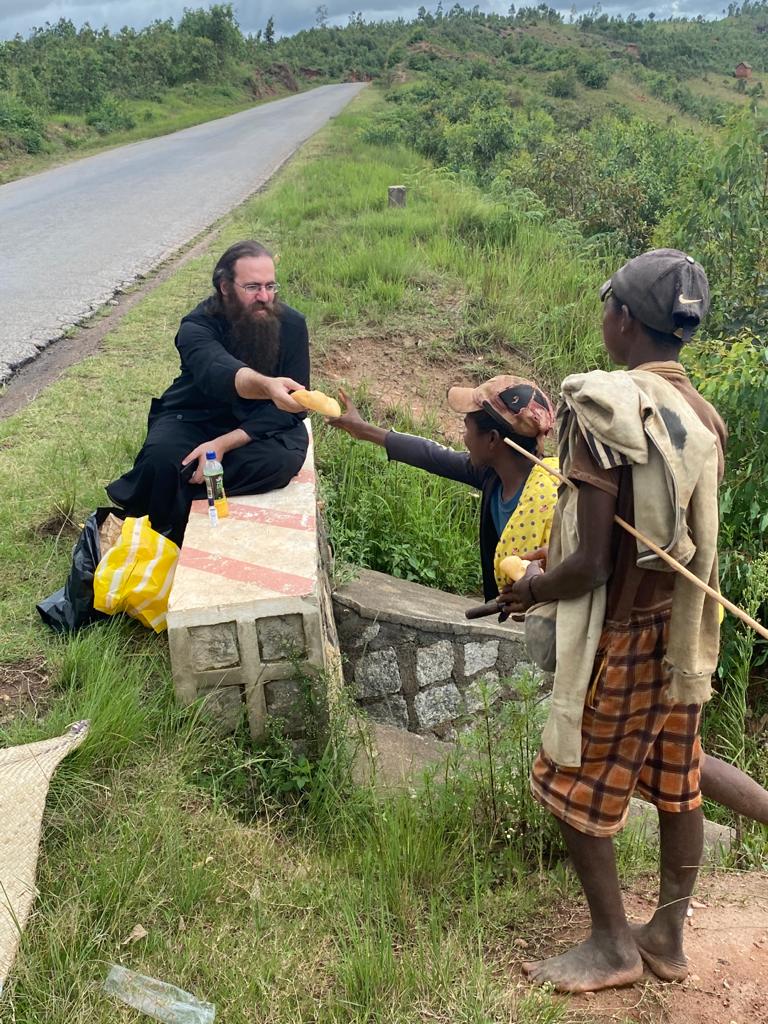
[106,241,309,544]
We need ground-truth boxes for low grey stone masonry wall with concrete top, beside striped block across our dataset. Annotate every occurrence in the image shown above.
[334,570,525,739]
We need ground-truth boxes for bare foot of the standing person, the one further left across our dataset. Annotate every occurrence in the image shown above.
[522,937,643,992]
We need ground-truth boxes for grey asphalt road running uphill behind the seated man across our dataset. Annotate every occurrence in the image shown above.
[0,84,361,383]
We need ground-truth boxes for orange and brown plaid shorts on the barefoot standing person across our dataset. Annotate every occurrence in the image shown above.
[530,611,701,837]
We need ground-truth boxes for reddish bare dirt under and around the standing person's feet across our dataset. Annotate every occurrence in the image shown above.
[518,871,768,1024]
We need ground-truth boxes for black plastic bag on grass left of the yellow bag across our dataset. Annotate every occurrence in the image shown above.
[37,508,125,633]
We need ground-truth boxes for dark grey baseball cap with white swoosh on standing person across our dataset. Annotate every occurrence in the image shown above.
[600,249,710,341]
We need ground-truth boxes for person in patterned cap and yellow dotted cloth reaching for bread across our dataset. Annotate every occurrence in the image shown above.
[329,375,557,601]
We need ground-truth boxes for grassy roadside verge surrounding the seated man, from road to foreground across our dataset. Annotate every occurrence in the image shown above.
[0,95,655,1024]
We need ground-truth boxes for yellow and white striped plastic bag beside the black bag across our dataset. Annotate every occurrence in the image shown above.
[93,515,179,633]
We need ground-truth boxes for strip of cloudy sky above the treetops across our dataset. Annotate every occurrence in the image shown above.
[0,0,724,39]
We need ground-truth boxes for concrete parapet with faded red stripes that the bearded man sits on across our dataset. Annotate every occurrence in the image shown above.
[168,421,341,738]
